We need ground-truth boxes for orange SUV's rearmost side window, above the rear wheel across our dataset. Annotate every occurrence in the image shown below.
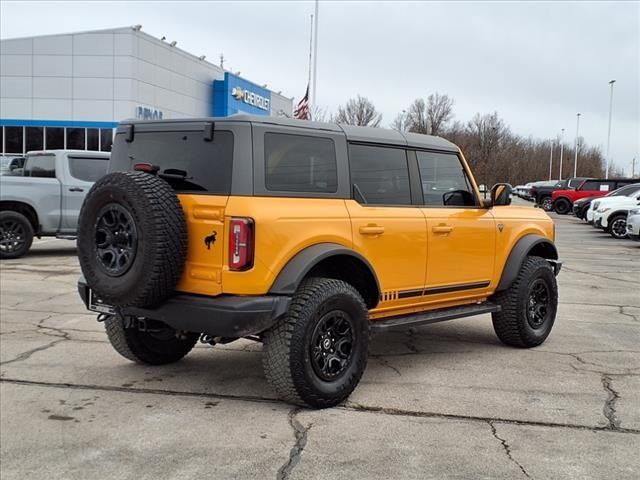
[264,133,338,193]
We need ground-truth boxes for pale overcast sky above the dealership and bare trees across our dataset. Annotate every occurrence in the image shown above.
[0,0,640,173]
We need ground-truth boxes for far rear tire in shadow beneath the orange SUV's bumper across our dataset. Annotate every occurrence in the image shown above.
[104,315,198,365]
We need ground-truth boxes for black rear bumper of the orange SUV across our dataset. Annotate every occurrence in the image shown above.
[78,279,291,338]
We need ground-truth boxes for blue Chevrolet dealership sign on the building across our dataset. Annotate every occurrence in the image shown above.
[212,72,271,117]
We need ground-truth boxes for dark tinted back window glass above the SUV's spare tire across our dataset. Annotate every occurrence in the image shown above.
[109,130,233,195]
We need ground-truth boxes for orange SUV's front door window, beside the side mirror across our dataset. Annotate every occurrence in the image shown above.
[416,152,475,206]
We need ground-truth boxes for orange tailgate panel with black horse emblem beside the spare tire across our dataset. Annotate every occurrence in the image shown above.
[176,194,229,296]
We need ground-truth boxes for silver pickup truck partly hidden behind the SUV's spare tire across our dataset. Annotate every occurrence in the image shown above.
[0,150,109,258]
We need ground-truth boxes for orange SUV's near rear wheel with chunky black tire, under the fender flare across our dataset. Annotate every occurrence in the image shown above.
[262,278,369,408]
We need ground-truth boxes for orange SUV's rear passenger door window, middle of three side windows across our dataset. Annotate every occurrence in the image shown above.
[349,145,411,205]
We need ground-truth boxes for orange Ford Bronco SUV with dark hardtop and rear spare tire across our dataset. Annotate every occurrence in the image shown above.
[78,115,561,407]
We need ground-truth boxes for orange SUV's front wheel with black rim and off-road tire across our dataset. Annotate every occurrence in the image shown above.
[492,257,558,348]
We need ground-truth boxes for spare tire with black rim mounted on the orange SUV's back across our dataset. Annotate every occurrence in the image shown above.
[78,172,187,307]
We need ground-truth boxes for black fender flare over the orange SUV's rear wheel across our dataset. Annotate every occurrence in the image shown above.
[269,243,381,298]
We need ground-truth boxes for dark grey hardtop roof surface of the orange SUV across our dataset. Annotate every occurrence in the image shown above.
[120,114,460,152]
